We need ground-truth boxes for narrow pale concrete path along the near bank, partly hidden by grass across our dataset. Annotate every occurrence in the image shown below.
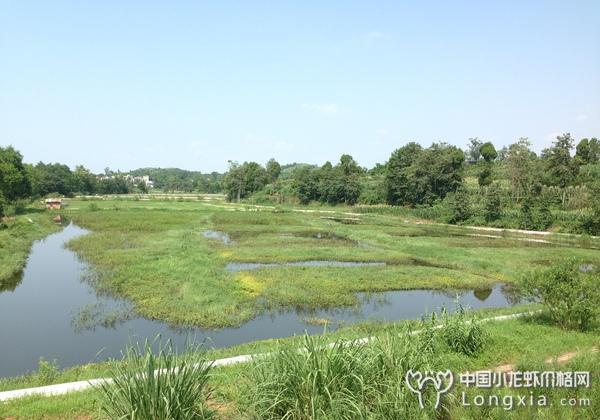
[0,311,538,402]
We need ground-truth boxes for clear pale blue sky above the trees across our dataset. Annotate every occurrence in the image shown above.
[0,0,600,172]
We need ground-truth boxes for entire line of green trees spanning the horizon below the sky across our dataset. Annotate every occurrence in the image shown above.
[0,133,600,233]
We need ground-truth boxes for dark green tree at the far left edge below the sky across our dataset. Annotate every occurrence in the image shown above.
[0,146,31,208]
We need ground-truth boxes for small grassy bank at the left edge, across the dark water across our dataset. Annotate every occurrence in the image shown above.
[0,208,60,291]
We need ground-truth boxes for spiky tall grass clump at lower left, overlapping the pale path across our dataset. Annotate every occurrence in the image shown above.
[100,341,213,420]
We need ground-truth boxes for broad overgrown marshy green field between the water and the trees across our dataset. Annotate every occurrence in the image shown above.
[52,200,600,327]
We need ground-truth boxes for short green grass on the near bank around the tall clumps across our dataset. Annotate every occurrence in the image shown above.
[0,310,600,419]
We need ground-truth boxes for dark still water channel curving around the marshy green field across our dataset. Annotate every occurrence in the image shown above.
[0,225,510,376]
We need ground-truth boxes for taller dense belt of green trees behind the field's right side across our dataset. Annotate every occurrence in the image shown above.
[223,133,600,233]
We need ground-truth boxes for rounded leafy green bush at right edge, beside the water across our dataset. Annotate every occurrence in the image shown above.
[521,258,600,330]
